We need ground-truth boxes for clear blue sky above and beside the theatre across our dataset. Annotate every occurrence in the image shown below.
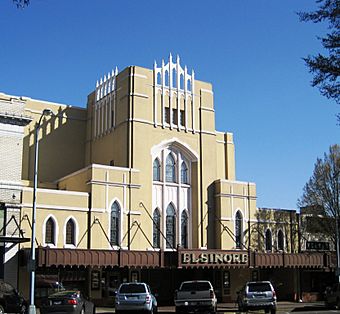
[0,0,340,208]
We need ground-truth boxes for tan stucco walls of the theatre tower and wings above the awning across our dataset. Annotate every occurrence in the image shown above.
[17,60,266,255]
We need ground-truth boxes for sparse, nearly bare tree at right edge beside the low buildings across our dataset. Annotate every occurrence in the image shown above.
[298,144,340,243]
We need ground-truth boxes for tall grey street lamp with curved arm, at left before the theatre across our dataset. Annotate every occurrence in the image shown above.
[28,109,53,314]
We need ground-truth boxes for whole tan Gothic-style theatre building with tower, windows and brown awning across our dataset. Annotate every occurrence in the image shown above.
[0,55,334,305]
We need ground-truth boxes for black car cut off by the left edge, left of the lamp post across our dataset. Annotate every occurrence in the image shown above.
[0,279,28,314]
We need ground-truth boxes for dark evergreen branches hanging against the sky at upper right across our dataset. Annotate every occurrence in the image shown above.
[299,0,340,106]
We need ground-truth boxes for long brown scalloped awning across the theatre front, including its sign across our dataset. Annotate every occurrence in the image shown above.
[29,247,335,270]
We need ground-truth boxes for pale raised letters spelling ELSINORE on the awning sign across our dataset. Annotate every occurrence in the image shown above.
[181,253,248,264]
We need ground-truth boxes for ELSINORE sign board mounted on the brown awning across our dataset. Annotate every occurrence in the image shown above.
[179,250,249,266]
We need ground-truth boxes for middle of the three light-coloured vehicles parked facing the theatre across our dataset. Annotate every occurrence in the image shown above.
[175,280,217,313]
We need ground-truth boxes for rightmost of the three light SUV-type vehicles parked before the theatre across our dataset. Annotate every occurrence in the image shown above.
[237,281,276,314]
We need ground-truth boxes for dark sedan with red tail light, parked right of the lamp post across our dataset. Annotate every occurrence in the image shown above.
[40,290,95,314]
